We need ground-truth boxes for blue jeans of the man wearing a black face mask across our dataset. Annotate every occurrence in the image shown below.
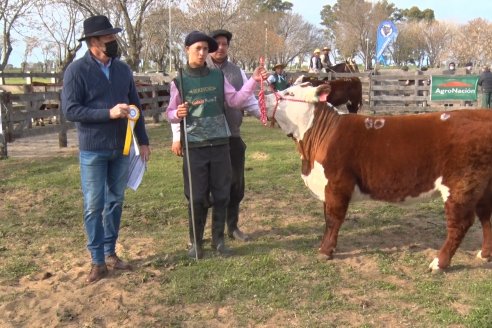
[79,150,130,265]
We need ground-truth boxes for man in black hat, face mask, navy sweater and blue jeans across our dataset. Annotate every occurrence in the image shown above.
[62,16,150,283]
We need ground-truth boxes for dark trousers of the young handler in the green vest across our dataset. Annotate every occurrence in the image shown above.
[183,144,232,244]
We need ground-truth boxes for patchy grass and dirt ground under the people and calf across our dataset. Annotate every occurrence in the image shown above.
[0,118,492,327]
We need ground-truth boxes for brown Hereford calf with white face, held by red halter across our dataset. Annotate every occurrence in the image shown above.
[266,85,492,272]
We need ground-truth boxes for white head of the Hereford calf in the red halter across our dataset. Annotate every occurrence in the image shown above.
[265,84,320,140]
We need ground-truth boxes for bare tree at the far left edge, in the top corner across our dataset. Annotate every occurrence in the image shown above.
[0,0,34,70]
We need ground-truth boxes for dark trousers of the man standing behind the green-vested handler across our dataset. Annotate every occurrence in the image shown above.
[227,137,246,233]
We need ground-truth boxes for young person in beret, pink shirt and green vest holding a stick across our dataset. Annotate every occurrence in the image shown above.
[166,31,267,258]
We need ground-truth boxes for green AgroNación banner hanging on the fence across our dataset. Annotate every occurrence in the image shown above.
[431,75,479,101]
